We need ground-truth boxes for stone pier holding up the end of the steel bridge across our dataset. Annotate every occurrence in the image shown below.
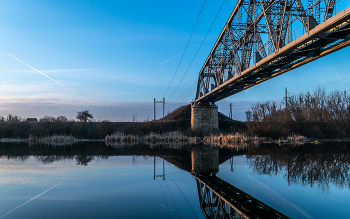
[191,102,219,130]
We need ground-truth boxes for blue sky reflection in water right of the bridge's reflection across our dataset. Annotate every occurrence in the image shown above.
[217,155,350,218]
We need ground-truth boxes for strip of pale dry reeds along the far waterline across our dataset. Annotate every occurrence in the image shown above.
[0,131,344,148]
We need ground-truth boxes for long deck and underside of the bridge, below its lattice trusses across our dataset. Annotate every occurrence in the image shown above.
[196,8,350,102]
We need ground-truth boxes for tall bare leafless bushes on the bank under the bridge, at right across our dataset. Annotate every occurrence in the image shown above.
[246,88,350,138]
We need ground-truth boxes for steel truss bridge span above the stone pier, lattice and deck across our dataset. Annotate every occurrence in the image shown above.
[195,0,350,103]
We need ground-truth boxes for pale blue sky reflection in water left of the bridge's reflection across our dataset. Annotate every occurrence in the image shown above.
[0,157,203,218]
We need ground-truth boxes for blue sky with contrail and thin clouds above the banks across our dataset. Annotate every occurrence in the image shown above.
[0,0,350,121]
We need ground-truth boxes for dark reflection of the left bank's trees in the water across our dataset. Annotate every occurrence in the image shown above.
[0,143,191,166]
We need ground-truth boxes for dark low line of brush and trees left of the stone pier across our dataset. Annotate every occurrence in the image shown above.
[0,110,191,139]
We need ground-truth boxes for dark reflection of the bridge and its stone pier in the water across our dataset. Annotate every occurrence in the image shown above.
[191,149,288,219]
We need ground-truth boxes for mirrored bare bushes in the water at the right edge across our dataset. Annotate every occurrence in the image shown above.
[246,145,350,191]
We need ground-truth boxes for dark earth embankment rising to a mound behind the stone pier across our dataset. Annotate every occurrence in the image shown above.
[0,105,246,141]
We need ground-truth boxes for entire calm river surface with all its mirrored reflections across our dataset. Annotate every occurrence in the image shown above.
[0,143,350,218]
